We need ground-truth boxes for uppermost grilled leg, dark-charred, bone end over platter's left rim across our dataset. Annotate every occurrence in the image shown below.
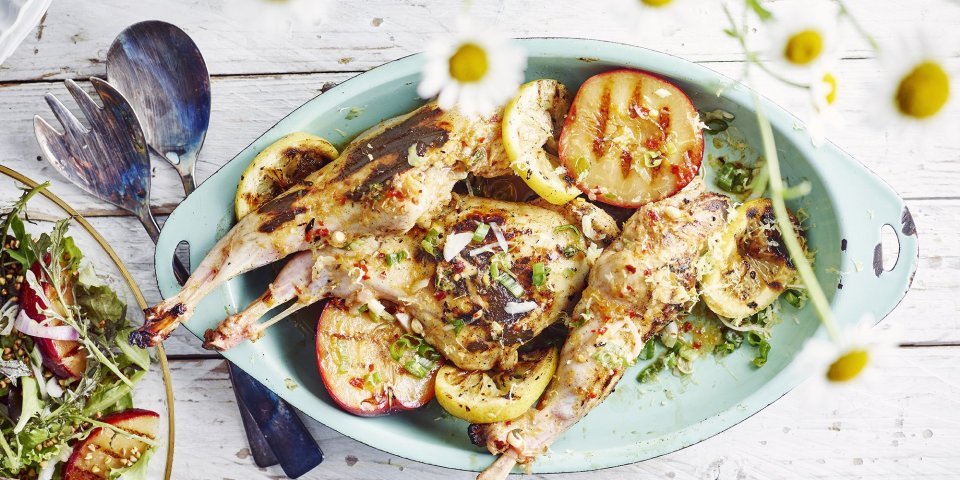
[130,102,511,346]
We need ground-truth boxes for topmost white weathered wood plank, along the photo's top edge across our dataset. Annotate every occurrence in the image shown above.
[0,0,960,81]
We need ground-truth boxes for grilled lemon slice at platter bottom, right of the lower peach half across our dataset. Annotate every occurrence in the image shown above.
[435,348,559,423]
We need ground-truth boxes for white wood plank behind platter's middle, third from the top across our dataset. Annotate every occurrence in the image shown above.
[69,200,960,354]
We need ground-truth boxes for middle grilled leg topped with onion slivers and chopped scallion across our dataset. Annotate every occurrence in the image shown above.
[206,197,618,370]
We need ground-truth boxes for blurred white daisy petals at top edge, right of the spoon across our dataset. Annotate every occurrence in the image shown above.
[228,0,332,33]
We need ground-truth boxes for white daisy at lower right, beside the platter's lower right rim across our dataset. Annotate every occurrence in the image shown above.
[796,315,897,398]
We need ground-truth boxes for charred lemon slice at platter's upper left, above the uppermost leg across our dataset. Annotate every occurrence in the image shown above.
[234,132,340,220]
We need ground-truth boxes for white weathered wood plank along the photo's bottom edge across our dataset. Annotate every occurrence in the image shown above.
[159,347,960,480]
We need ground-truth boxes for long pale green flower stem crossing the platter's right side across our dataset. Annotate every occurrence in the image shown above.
[753,93,840,341]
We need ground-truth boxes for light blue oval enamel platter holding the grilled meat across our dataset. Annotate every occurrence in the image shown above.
[156,38,918,472]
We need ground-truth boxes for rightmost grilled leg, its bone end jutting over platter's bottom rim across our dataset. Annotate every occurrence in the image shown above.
[470,179,730,479]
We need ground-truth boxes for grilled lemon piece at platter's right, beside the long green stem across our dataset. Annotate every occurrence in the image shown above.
[701,198,803,319]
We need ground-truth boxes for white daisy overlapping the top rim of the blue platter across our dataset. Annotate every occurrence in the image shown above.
[417,21,527,116]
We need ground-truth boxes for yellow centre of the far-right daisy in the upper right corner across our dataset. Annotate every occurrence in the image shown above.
[895,60,950,118]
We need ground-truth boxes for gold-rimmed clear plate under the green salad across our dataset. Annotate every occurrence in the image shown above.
[0,165,174,479]
